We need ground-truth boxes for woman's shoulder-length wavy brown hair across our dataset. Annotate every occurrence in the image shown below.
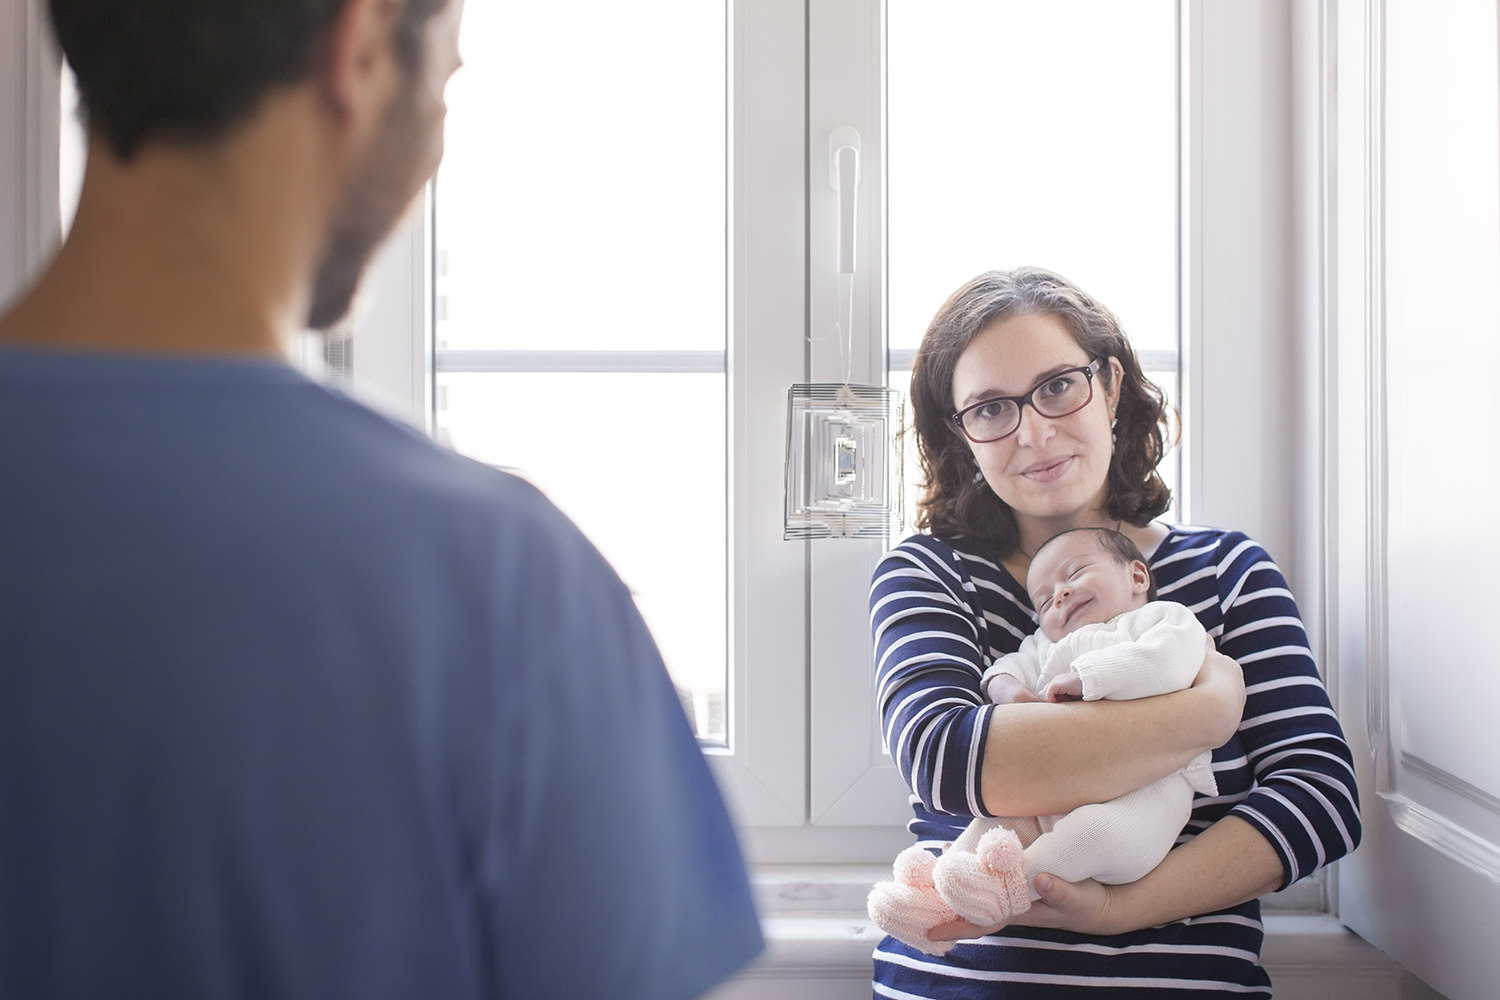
[911,267,1175,556]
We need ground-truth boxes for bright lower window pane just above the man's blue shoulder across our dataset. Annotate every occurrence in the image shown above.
[438,372,729,744]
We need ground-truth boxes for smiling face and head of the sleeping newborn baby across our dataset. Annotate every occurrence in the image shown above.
[1026,531,1151,642]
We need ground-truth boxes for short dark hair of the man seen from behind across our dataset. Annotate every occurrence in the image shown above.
[48,0,449,160]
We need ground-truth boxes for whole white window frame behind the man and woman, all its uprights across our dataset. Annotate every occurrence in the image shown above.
[0,0,1337,893]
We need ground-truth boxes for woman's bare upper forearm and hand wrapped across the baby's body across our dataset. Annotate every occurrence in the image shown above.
[981,654,1245,816]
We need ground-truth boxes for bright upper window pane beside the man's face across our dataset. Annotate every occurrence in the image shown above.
[437,0,726,351]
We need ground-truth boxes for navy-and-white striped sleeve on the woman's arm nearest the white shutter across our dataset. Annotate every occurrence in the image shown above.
[1215,534,1361,888]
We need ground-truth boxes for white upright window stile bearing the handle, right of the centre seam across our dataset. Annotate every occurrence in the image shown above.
[807,0,908,829]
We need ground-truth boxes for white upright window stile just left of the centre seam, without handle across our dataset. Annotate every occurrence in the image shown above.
[710,0,809,839]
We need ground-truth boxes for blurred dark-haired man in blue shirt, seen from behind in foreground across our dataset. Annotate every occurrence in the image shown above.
[0,0,761,1000]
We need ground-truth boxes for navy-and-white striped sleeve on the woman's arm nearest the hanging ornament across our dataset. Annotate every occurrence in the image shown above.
[870,537,995,816]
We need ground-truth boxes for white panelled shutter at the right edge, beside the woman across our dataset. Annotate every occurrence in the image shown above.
[1325,0,1500,1000]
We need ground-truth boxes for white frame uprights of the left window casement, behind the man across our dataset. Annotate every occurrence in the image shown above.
[353,0,822,856]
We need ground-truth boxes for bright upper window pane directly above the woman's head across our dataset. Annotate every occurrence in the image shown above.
[887,0,1178,358]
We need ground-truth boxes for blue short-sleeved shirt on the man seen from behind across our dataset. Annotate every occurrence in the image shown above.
[0,349,761,1000]
